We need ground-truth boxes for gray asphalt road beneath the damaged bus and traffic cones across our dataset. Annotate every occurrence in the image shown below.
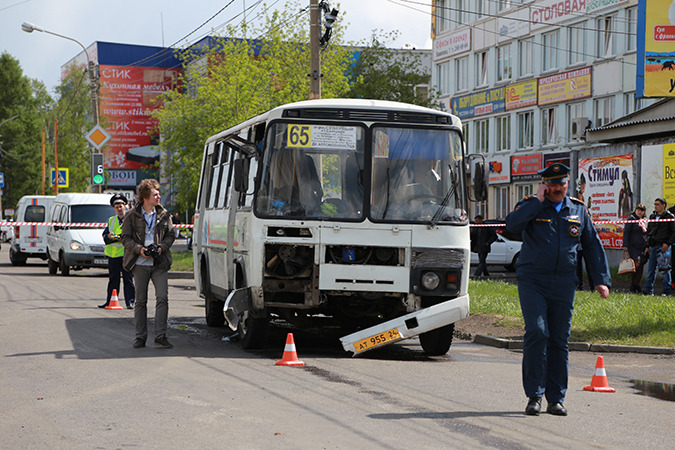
[0,245,675,449]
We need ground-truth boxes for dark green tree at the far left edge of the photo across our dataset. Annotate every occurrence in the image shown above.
[0,52,52,207]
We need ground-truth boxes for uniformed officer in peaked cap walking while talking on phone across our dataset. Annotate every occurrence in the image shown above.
[506,163,611,416]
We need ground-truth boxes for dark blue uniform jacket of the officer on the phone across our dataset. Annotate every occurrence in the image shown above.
[506,196,612,286]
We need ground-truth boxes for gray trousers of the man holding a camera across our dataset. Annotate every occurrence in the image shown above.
[132,265,169,341]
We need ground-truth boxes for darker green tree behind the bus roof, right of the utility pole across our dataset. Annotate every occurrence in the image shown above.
[347,31,438,108]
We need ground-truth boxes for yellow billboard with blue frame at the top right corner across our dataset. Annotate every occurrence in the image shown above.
[635,0,675,98]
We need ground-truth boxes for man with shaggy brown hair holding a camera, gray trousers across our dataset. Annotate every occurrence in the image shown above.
[122,179,176,348]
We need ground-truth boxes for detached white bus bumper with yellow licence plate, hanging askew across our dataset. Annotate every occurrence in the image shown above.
[340,294,469,356]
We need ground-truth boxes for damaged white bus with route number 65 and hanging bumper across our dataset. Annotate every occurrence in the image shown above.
[193,99,486,355]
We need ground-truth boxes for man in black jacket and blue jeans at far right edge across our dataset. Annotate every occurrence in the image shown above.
[642,198,675,295]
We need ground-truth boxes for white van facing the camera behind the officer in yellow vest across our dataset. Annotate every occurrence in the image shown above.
[47,194,115,276]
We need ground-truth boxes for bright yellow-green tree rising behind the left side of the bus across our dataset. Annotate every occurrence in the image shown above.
[153,1,349,210]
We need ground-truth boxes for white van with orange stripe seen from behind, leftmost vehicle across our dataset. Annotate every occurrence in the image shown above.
[9,195,54,266]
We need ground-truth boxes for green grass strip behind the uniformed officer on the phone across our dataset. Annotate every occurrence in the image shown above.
[469,280,675,347]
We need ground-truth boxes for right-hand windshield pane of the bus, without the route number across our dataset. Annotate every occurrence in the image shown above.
[370,127,467,223]
